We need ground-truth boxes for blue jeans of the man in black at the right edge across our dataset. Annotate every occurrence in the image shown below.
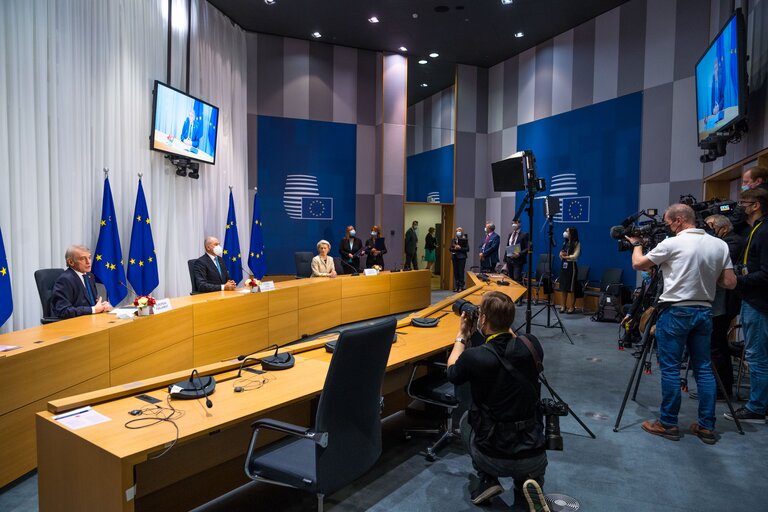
[741,301,768,414]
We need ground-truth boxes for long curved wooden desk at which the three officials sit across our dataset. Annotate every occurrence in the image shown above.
[0,270,430,487]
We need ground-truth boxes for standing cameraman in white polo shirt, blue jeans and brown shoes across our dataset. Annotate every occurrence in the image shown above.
[627,204,736,444]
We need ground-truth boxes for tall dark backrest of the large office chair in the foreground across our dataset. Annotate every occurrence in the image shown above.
[315,317,397,495]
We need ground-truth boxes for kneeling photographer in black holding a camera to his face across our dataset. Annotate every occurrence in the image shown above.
[448,292,547,510]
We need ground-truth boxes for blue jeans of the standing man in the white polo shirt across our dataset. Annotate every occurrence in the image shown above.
[656,306,716,430]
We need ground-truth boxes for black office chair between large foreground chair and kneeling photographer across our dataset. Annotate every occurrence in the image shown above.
[404,361,460,462]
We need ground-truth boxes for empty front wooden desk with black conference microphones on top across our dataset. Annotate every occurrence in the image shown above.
[36,274,524,511]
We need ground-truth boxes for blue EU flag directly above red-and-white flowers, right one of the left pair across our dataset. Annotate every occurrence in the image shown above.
[128,178,160,295]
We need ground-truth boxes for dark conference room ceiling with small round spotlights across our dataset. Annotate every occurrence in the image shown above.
[208,0,628,104]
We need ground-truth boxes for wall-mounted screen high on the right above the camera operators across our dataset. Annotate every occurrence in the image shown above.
[696,10,747,143]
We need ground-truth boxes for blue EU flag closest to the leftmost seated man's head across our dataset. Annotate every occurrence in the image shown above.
[92,178,128,305]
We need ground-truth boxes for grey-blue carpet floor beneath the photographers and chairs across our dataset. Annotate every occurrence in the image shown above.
[0,297,768,512]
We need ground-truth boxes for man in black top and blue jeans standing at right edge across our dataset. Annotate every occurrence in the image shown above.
[725,189,768,423]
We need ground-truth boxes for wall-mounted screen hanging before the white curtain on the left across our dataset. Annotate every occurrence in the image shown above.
[150,80,219,164]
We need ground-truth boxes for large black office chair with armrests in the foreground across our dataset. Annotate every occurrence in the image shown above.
[245,317,396,512]
